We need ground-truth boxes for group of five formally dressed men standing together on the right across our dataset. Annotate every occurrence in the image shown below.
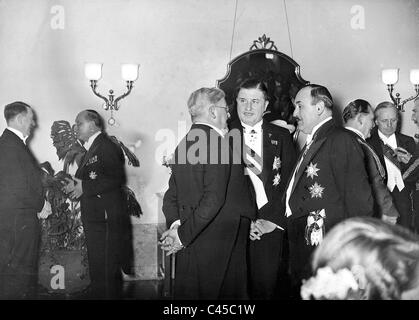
[160,79,419,299]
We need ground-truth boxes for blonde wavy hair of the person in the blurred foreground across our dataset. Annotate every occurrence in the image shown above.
[312,217,419,300]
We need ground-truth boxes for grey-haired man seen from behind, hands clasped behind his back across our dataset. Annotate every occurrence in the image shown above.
[161,88,256,299]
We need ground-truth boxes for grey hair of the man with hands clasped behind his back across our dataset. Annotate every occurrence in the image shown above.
[188,87,225,122]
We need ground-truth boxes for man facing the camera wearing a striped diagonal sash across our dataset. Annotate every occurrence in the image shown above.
[231,79,296,300]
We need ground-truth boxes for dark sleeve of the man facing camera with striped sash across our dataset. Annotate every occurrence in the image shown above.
[258,134,297,228]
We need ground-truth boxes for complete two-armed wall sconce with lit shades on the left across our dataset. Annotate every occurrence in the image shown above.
[84,63,140,126]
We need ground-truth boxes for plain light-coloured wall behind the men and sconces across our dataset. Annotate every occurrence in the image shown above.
[0,0,419,223]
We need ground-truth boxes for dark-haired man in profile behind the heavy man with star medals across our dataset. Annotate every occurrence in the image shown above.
[342,99,399,224]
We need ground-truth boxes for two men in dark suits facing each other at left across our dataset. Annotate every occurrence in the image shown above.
[0,101,129,299]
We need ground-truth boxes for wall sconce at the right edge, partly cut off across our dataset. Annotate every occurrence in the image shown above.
[381,69,419,112]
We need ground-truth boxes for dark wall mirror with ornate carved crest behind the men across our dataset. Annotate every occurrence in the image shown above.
[216,34,310,124]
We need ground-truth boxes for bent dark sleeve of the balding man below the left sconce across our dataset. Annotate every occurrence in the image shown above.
[82,141,125,196]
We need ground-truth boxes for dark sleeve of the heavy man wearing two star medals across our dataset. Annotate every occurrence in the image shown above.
[332,133,374,224]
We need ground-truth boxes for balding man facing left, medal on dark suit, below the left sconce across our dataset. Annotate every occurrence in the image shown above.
[64,110,129,299]
